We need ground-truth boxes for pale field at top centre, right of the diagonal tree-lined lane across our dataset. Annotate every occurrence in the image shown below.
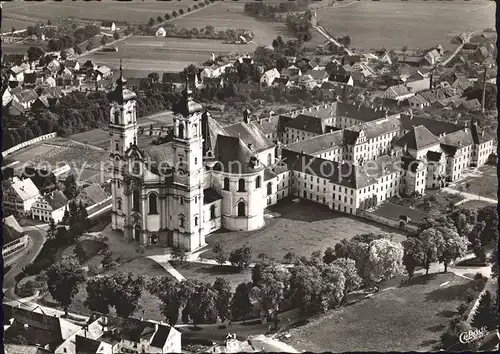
[171,1,288,45]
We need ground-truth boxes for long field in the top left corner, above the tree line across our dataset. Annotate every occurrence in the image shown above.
[2,0,189,31]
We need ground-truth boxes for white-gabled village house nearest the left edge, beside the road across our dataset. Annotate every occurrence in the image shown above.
[2,176,40,216]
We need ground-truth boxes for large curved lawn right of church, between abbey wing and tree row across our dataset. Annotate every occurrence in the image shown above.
[202,200,404,262]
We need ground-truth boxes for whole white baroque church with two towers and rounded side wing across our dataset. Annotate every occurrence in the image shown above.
[108,70,290,251]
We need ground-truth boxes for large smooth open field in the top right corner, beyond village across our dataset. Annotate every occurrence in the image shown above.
[309,0,495,50]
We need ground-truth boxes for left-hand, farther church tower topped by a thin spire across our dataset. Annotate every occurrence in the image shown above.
[108,60,137,230]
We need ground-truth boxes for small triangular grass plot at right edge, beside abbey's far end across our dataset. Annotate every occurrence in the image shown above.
[450,165,498,199]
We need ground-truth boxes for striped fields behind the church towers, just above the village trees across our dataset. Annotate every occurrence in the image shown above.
[82,36,256,77]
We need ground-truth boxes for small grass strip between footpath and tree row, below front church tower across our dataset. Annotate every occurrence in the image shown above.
[170,261,252,291]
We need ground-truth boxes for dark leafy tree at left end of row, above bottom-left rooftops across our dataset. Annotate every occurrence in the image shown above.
[47,257,85,317]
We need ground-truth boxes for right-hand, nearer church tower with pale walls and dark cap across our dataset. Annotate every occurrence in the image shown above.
[172,83,205,251]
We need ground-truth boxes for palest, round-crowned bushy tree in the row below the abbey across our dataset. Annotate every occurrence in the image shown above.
[368,239,404,282]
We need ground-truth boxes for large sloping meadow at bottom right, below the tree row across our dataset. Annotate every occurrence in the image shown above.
[290,273,484,352]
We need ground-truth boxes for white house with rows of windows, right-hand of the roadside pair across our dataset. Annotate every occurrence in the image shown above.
[31,190,68,224]
